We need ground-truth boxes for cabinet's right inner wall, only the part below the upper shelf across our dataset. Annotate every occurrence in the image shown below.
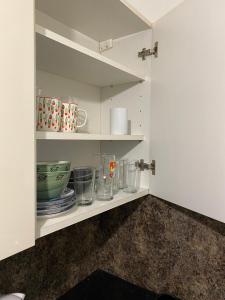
[101,82,151,188]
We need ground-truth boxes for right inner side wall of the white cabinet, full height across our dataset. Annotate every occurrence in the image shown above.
[101,30,152,188]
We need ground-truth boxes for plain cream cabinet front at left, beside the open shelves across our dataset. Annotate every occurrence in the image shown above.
[0,0,35,259]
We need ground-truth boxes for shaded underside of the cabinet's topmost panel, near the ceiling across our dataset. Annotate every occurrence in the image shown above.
[36,0,150,41]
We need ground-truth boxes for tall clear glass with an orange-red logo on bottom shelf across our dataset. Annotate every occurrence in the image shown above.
[96,154,116,200]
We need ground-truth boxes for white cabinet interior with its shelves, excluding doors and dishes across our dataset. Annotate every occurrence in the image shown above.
[36,1,152,238]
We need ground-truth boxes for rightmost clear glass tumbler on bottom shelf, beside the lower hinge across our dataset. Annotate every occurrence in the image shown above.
[124,161,141,193]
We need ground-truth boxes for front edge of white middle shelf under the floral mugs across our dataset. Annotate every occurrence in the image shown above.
[36,131,144,141]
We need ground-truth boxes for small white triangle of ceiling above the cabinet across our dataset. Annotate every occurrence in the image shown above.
[121,0,184,23]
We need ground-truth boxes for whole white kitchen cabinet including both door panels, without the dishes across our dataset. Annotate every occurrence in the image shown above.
[0,0,225,258]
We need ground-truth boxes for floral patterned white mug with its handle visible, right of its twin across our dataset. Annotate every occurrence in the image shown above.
[60,102,87,132]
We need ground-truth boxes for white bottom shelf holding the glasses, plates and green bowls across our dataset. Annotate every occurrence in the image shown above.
[36,189,149,238]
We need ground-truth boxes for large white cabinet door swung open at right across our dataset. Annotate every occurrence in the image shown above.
[150,0,225,222]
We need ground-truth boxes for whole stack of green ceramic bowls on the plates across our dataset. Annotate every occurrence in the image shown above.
[37,161,71,201]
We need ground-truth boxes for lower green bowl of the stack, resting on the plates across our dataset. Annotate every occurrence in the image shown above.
[37,171,70,200]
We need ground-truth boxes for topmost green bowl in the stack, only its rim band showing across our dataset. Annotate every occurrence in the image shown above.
[37,161,71,172]
